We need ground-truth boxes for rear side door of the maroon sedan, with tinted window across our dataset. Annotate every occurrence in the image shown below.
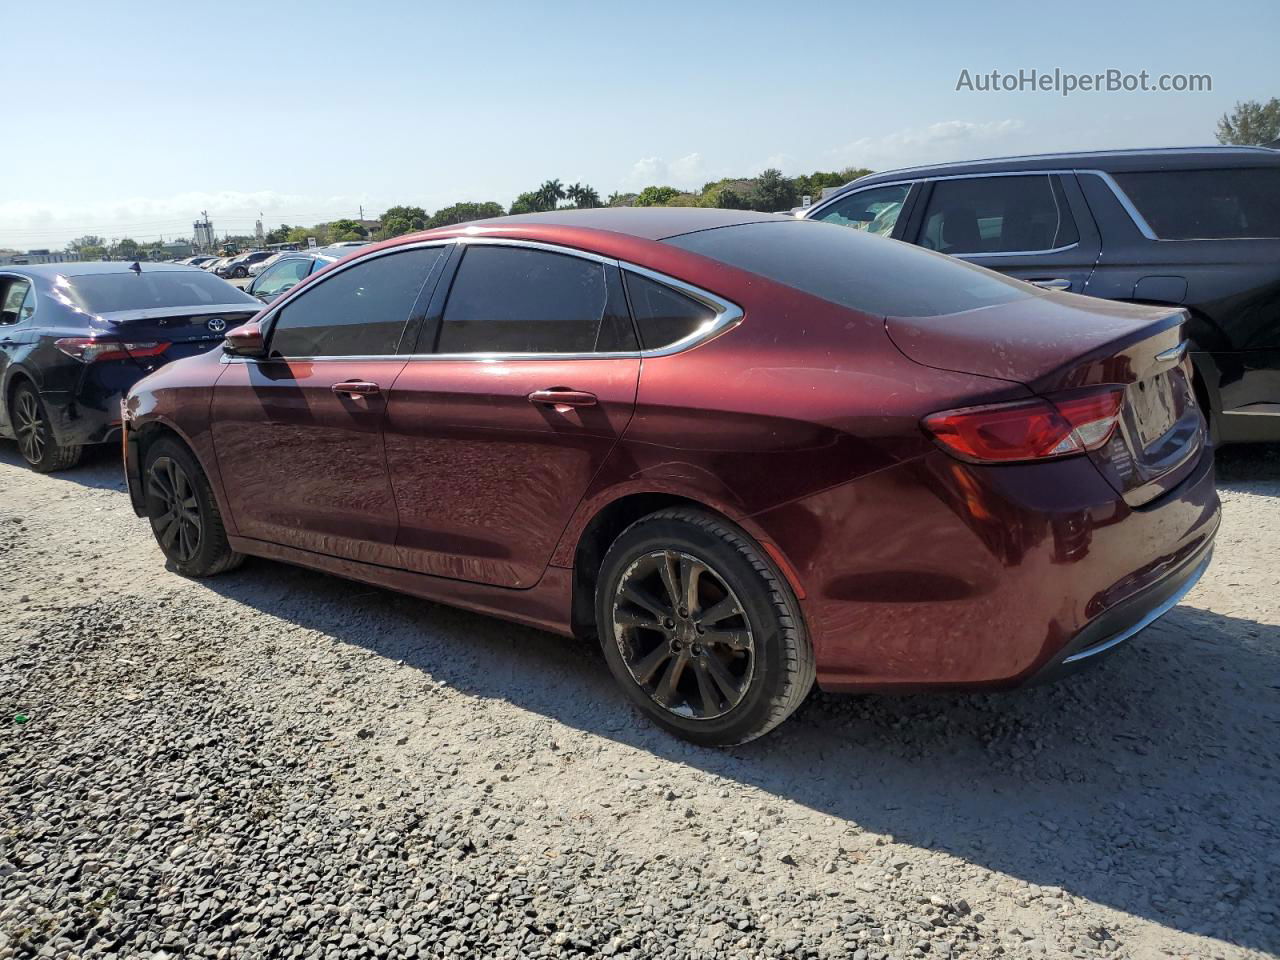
[385,241,640,588]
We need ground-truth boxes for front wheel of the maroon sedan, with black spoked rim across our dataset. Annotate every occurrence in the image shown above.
[142,436,244,577]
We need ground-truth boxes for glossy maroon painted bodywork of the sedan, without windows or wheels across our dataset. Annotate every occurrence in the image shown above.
[127,211,1219,690]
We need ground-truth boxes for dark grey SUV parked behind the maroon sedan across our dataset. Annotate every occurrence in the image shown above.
[800,147,1280,443]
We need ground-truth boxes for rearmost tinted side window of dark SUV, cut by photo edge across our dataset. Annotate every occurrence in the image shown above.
[1115,166,1280,239]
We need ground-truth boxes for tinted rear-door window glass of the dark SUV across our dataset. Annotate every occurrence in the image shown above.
[920,174,1080,253]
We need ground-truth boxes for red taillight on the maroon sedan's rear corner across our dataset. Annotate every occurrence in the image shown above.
[920,385,1124,463]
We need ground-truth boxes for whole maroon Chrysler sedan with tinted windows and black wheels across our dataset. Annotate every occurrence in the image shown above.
[125,209,1219,745]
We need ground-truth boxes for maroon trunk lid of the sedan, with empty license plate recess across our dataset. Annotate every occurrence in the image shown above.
[886,293,1204,506]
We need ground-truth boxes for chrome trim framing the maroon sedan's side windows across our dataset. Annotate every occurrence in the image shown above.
[238,236,745,364]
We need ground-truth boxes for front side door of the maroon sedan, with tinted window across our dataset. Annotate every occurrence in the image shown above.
[211,246,447,566]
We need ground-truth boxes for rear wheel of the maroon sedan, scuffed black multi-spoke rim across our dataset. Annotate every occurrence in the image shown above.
[595,507,815,746]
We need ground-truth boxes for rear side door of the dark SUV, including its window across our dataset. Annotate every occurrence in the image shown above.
[911,173,1100,293]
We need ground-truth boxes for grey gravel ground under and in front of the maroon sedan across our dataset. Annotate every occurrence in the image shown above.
[0,443,1280,960]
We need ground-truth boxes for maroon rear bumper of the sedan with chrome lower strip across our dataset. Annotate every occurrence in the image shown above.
[753,448,1220,691]
